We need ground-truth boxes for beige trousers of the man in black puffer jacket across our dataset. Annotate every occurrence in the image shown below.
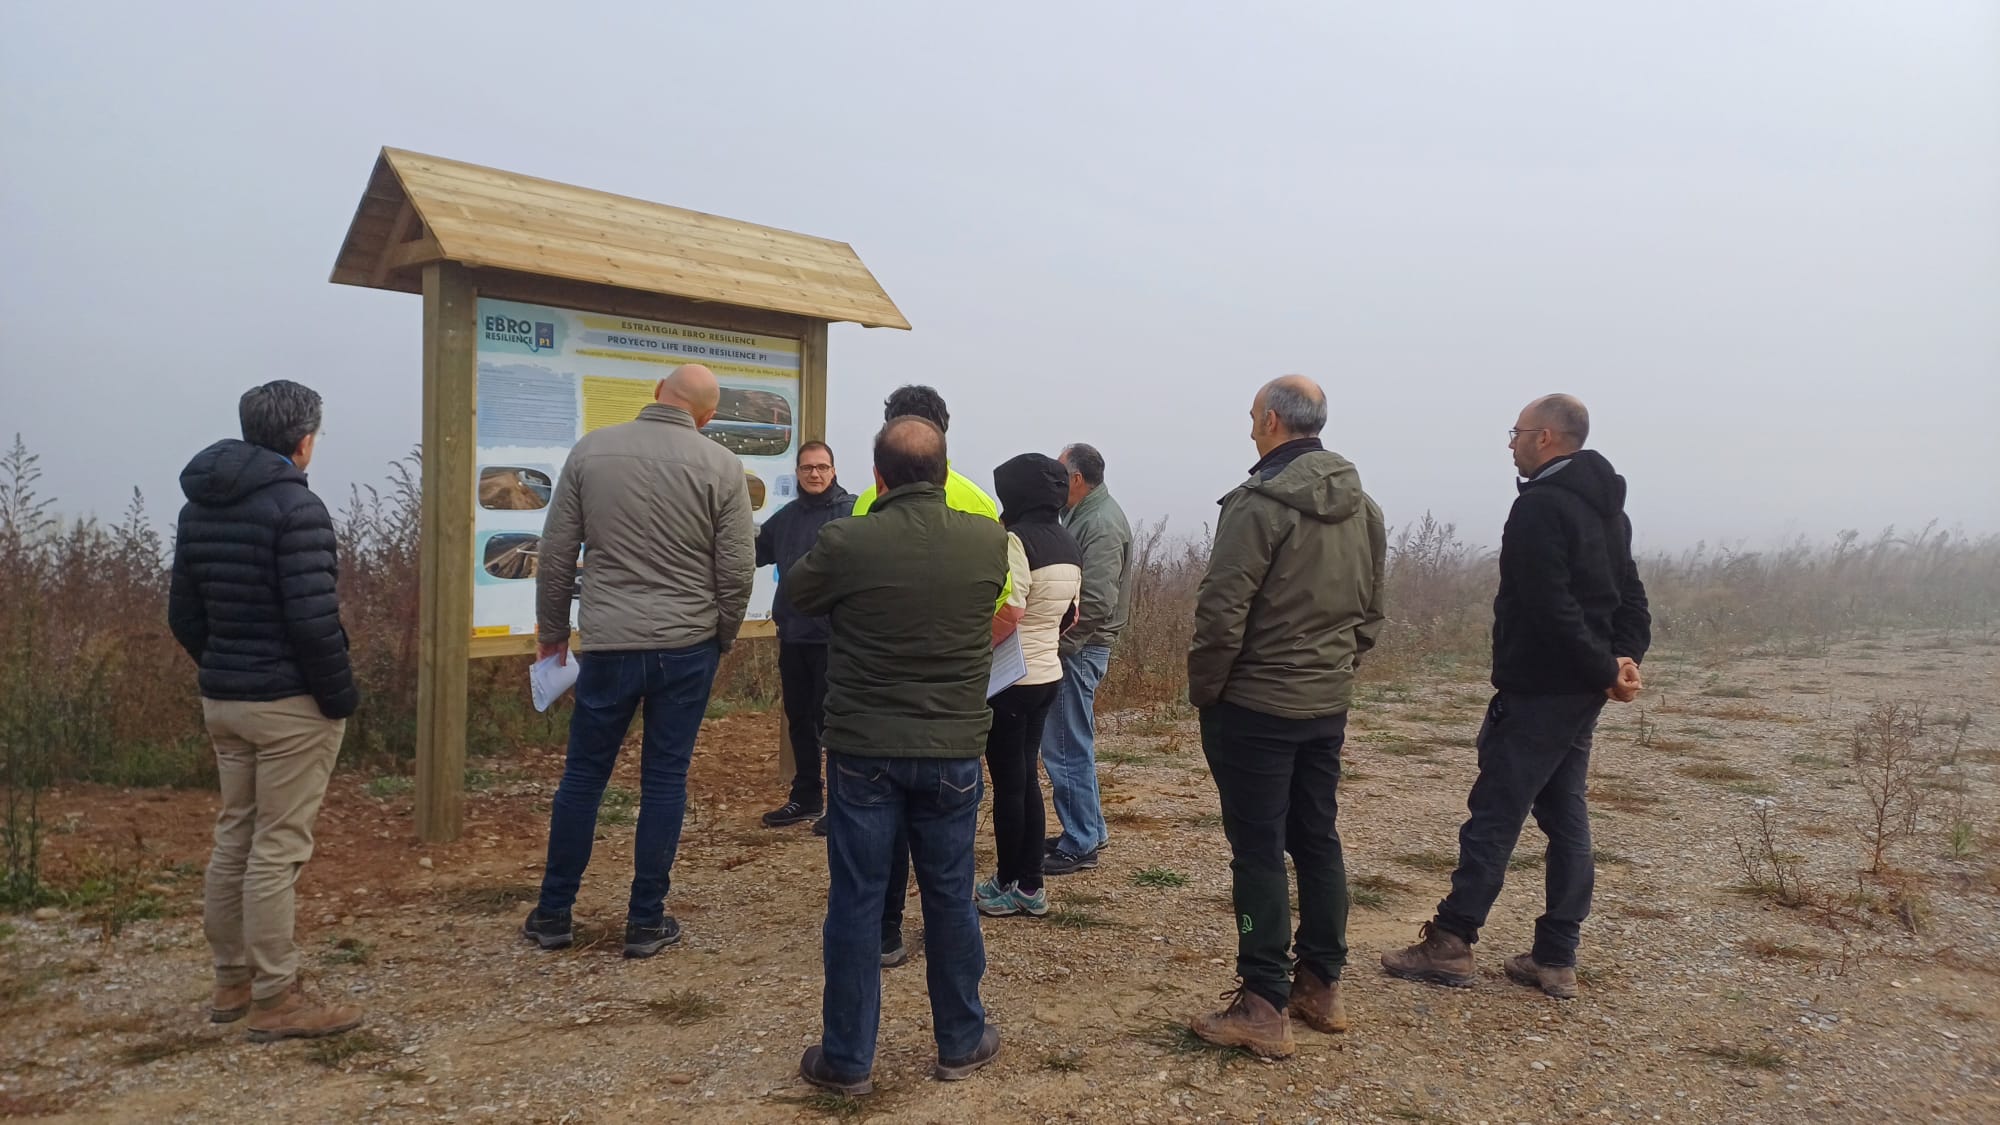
[202,695,348,999]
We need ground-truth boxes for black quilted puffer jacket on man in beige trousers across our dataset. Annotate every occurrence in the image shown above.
[166,438,360,719]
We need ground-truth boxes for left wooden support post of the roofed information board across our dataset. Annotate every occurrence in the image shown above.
[416,262,478,843]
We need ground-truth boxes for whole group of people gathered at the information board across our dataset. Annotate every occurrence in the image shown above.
[170,364,1650,1095]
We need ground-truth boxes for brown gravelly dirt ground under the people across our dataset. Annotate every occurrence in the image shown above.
[0,635,2000,1125]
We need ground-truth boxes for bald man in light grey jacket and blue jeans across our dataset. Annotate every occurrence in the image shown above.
[522,364,756,957]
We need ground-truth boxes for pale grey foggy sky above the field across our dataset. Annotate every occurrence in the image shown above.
[0,0,2000,548]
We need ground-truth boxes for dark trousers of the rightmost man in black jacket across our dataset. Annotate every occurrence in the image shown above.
[1436,691,1604,967]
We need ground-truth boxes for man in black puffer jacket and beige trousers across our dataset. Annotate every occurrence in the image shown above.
[166,378,362,1041]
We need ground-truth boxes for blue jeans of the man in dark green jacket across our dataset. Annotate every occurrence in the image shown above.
[820,751,986,1079]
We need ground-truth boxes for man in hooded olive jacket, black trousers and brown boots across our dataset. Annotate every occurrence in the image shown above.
[1188,374,1388,1057]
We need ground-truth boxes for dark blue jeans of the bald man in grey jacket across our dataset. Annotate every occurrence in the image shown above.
[540,641,720,925]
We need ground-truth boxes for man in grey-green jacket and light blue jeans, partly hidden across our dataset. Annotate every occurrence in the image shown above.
[1042,442,1132,875]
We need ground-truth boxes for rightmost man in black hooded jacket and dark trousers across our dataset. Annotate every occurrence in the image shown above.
[1382,394,1652,999]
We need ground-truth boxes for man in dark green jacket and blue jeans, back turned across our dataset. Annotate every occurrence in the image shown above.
[778,416,1008,1095]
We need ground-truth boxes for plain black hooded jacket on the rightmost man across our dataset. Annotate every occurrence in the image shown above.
[1494,448,1652,695]
